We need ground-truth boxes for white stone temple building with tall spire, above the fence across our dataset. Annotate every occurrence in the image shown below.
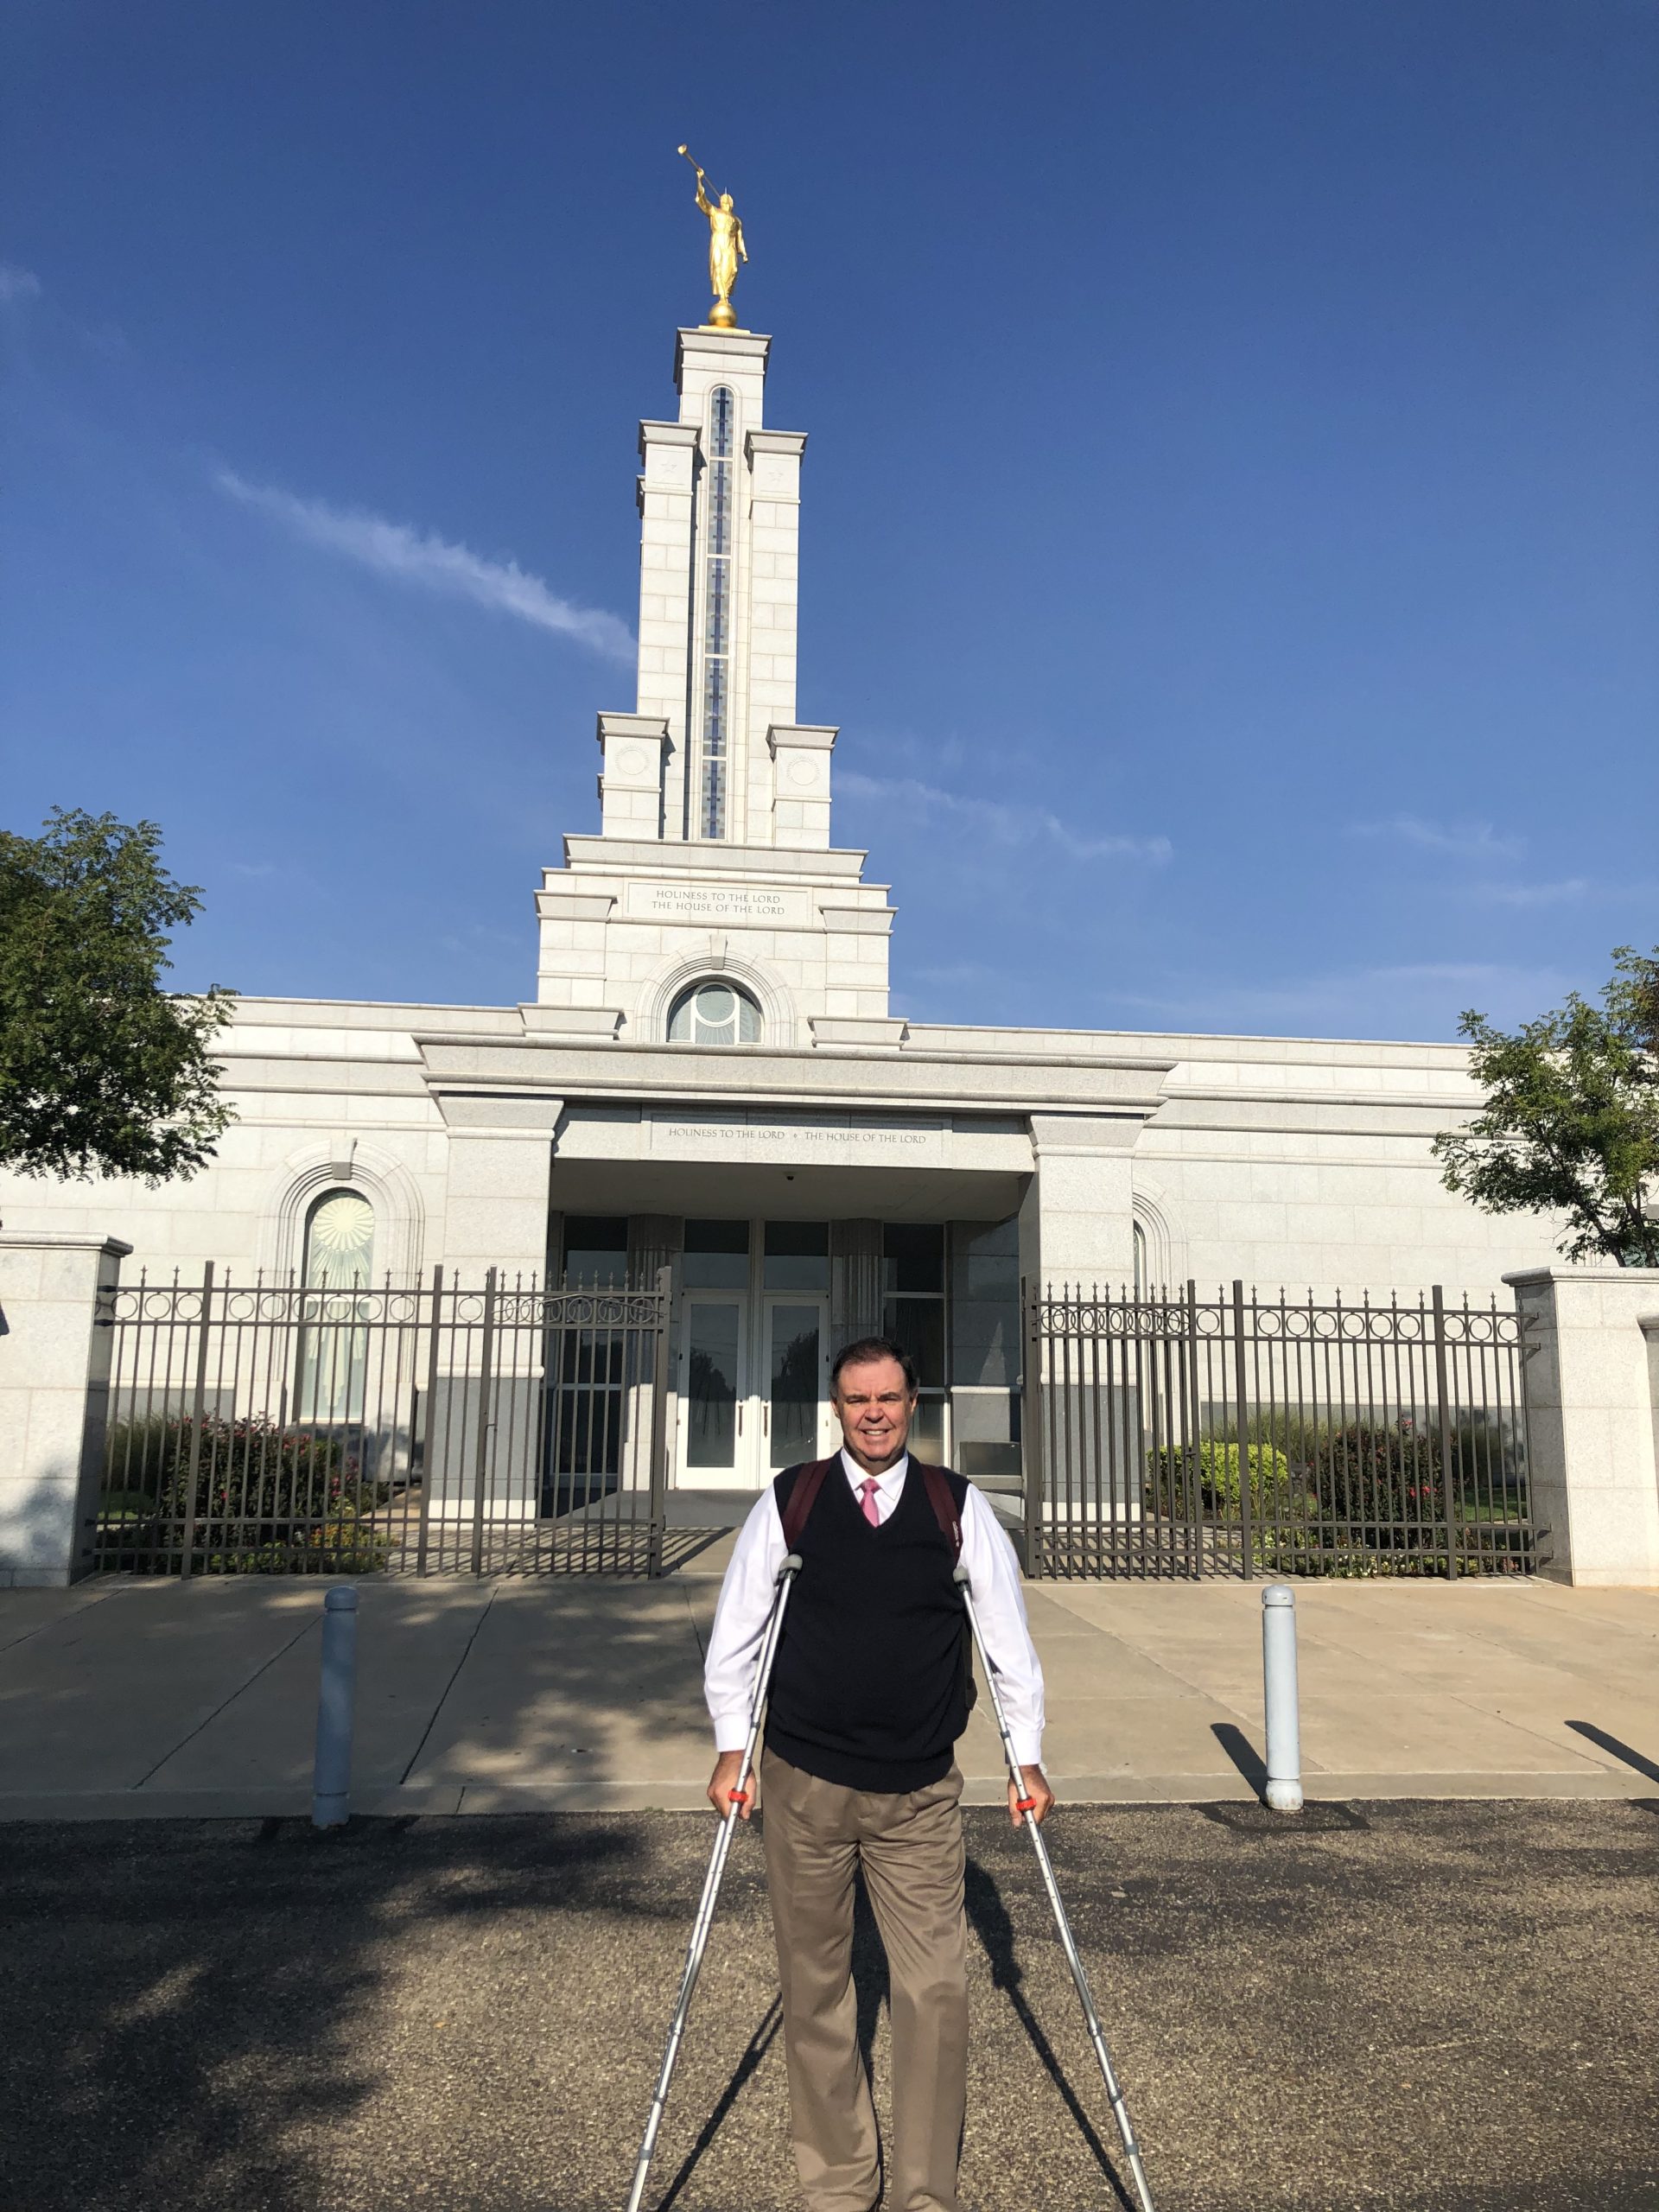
[0,311,1553,1491]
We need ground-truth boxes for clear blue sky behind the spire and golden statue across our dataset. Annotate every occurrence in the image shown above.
[0,0,1659,1038]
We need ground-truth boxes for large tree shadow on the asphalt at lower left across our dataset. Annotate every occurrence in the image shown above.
[0,1821,639,2212]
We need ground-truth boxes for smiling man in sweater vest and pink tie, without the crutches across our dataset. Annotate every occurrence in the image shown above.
[703,1338,1053,2212]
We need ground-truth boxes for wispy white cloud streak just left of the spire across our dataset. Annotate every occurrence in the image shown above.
[214,469,632,661]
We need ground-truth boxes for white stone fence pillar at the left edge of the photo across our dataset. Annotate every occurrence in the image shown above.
[0,1230,133,1588]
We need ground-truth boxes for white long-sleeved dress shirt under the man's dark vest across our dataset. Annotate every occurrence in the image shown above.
[703,1451,1042,1767]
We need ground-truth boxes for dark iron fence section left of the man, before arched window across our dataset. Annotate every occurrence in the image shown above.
[95,1268,668,1575]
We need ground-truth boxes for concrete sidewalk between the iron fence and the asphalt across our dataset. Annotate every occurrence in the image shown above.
[0,1541,1659,1818]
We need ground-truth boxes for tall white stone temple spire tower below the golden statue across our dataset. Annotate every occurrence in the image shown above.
[533,323,905,1048]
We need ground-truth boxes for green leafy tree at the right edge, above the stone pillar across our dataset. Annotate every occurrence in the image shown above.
[1433,944,1659,1268]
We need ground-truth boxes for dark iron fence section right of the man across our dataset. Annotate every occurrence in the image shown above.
[1022,1283,1535,1580]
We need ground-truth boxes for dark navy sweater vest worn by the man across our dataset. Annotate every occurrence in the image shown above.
[766,1460,973,1794]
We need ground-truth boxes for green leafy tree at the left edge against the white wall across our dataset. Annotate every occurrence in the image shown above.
[0,807,234,1184]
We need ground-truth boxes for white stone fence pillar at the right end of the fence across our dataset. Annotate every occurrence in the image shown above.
[1504,1268,1659,1588]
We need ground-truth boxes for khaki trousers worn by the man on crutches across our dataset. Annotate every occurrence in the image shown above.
[761,1752,967,2212]
